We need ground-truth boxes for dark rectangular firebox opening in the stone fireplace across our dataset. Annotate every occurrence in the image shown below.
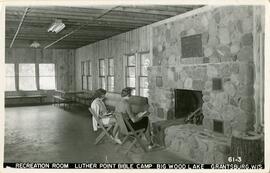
[174,89,203,120]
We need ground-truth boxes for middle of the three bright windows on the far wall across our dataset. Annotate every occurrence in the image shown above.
[19,64,37,91]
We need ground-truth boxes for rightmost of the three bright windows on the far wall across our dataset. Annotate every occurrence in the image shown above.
[39,64,56,90]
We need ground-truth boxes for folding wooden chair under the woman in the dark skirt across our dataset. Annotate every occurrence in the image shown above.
[115,113,147,154]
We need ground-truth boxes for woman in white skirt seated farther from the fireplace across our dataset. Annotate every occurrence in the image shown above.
[91,89,121,143]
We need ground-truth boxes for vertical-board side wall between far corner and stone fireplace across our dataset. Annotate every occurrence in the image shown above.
[75,26,150,92]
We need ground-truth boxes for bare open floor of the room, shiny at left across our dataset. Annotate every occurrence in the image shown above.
[4,105,190,163]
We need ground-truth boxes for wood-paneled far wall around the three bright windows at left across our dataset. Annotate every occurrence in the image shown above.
[5,48,75,94]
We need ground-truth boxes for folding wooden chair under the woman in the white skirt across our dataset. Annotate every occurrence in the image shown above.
[89,108,113,145]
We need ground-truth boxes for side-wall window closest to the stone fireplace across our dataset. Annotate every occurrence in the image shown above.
[139,53,150,97]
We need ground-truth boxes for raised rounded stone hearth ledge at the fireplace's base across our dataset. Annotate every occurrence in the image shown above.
[165,124,230,164]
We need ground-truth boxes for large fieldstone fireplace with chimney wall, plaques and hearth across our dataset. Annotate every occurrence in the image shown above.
[148,6,264,163]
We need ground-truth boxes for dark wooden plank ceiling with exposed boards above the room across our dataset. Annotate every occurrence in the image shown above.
[5,5,201,49]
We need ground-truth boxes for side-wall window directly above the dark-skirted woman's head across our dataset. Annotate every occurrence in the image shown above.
[126,55,136,95]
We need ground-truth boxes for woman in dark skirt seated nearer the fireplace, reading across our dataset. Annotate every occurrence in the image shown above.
[115,87,153,149]
